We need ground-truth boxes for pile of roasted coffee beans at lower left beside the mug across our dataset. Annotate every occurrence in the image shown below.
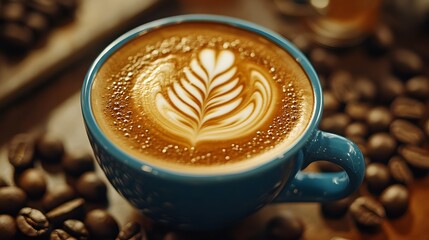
[0,134,146,240]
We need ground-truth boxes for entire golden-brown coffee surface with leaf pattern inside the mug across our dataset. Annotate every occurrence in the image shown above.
[91,22,314,171]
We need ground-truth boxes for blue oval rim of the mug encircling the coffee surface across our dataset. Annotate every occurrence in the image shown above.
[81,14,323,180]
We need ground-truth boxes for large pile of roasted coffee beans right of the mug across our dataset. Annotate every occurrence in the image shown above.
[303,25,429,236]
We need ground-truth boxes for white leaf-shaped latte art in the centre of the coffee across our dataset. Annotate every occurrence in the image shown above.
[133,48,277,147]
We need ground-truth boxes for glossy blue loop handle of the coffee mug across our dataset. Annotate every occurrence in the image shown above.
[273,130,365,202]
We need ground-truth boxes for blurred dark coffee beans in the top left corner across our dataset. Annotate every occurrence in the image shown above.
[0,0,78,56]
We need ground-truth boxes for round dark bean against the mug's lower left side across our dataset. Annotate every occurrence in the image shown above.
[76,172,107,202]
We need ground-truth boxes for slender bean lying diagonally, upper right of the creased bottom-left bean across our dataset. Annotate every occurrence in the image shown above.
[46,198,85,226]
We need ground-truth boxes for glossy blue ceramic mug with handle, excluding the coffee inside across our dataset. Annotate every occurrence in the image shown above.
[81,15,365,230]
